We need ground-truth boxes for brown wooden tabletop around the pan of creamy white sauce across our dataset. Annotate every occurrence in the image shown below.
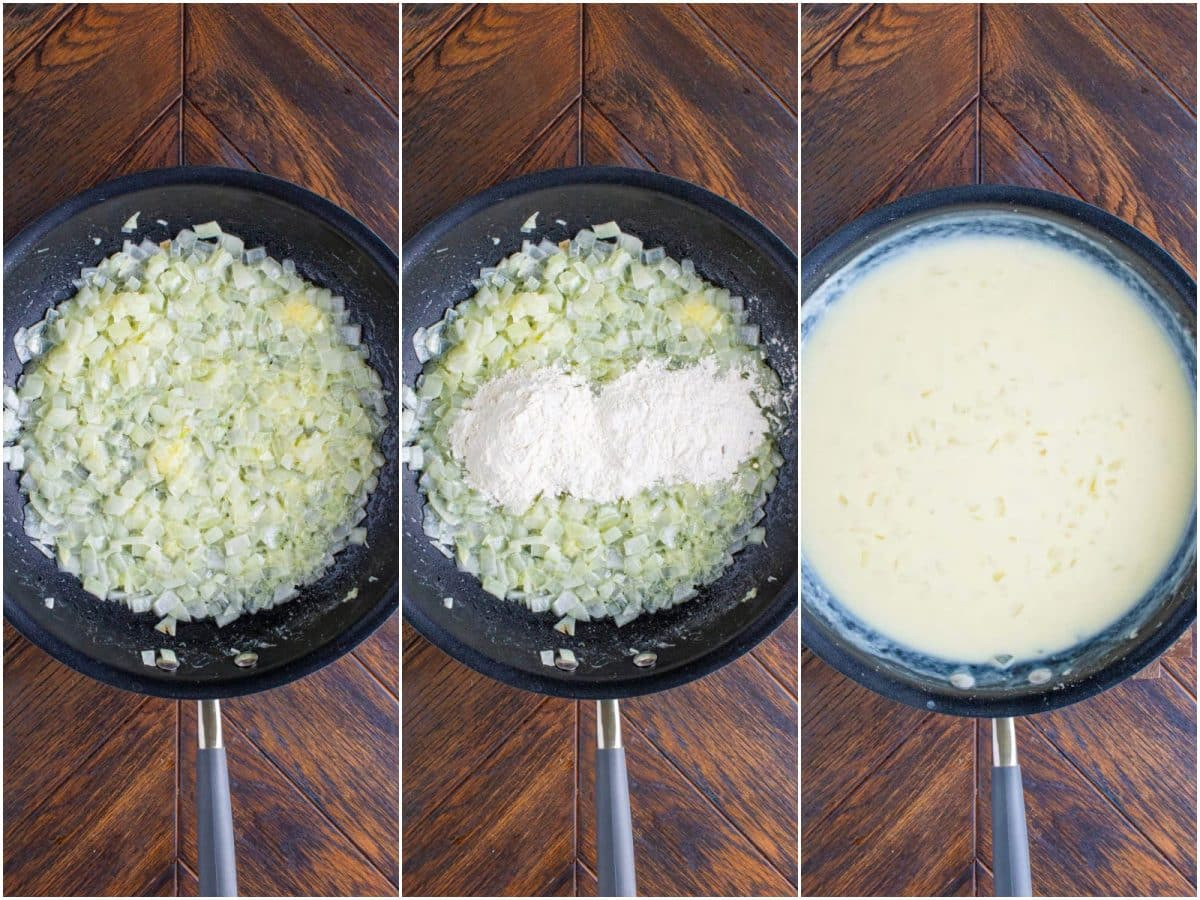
[800,5,1196,896]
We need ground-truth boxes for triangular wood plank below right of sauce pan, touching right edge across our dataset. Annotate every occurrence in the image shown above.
[1034,678,1196,882]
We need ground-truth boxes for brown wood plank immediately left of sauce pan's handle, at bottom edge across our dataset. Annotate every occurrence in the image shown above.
[800,715,974,896]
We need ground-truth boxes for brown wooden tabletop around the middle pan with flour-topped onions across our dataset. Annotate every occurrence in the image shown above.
[402,5,798,896]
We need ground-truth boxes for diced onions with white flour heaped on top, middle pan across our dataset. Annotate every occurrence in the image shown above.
[401,222,782,635]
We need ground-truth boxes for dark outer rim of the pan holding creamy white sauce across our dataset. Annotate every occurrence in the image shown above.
[800,184,1196,718]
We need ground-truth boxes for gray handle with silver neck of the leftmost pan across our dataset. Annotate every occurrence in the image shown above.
[196,700,238,896]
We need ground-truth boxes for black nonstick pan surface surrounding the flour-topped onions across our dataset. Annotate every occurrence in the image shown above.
[402,168,798,697]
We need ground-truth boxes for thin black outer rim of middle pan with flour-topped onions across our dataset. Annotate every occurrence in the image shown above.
[401,166,799,700]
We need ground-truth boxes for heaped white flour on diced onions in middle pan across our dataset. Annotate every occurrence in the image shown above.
[450,360,768,512]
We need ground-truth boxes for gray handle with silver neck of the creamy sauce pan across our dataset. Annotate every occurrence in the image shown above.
[991,719,1033,896]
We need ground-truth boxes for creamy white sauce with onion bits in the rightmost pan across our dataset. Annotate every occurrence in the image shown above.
[800,235,1195,662]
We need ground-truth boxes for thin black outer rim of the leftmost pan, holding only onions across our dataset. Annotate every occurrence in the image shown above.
[4,166,400,700]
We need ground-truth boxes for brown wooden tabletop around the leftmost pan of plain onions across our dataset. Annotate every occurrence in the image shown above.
[4,5,400,896]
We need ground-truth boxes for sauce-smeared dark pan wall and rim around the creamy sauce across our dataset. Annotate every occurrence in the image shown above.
[802,185,1196,716]
